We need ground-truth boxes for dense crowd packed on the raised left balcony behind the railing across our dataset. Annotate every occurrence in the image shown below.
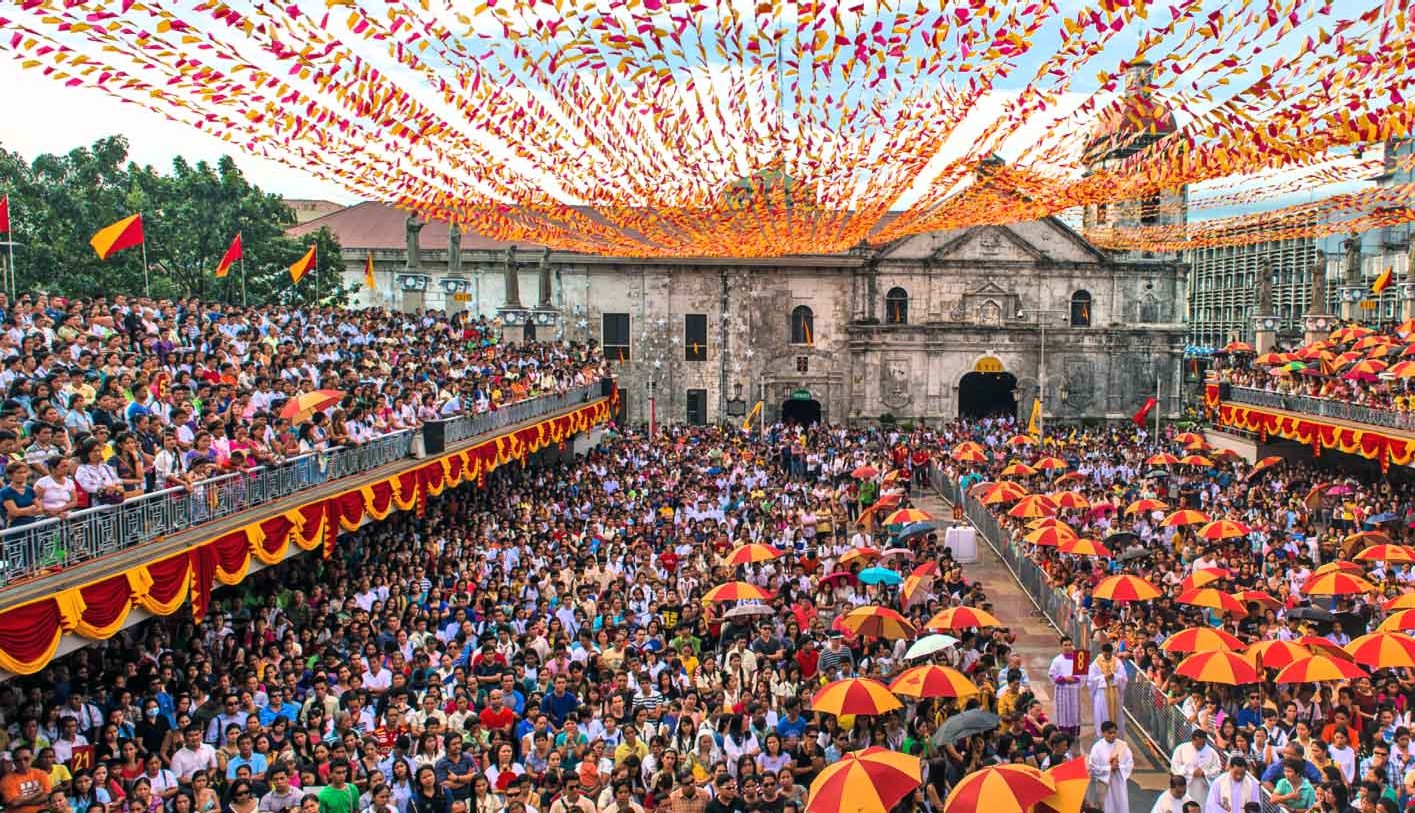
[0,296,600,527]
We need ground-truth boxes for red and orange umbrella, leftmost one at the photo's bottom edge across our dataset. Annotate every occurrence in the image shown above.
[804,745,924,813]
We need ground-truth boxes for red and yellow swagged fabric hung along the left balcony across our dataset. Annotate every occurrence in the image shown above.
[0,390,610,674]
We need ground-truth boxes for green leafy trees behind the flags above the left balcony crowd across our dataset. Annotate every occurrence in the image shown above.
[0,136,351,304]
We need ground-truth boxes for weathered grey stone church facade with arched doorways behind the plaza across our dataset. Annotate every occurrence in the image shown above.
[293,204,1186,423]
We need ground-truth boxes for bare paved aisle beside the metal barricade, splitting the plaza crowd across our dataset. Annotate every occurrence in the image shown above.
[916,496,1169,813]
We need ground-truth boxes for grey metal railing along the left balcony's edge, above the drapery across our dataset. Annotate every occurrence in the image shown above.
[0,382,601,585]
